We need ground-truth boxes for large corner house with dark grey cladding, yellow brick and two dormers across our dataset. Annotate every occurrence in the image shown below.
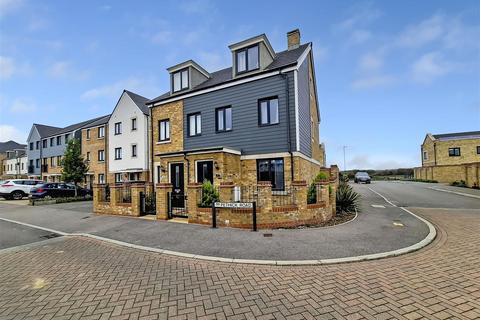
[148,29,325,199]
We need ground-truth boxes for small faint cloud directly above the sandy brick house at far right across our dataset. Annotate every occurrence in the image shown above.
[411,52,452,83]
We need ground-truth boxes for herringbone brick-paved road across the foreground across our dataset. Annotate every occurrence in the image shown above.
[0,209,480,319]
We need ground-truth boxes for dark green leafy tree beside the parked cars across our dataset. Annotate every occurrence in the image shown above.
[62,139,88,197]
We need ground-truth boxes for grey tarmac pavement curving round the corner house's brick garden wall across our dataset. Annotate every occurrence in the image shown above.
[0,182,438,261]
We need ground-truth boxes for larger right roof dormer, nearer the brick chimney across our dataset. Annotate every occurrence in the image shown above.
[228,34,275,78]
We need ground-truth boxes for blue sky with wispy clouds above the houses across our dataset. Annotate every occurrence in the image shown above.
[0,0,480,168]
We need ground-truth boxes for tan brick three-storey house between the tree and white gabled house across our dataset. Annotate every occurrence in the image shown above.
[82,115,110,189]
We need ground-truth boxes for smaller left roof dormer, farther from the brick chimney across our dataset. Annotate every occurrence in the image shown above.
[167,60,210,94]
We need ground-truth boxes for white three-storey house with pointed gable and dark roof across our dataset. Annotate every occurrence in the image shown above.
[105,90,150,183]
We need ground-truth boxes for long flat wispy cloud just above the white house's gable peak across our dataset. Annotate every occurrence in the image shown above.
[81,77,160,100]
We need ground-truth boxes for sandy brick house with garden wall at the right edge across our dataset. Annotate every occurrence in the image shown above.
[414,131,480,187]
